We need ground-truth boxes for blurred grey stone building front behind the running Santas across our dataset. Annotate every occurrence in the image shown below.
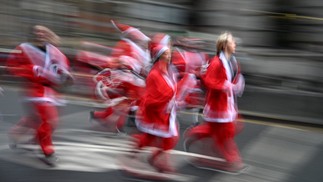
[0,0,323,124]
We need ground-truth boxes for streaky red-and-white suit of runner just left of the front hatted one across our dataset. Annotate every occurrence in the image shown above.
[92,68,146,130]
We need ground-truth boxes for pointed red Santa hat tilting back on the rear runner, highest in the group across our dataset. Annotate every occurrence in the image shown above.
[111,20,150,42]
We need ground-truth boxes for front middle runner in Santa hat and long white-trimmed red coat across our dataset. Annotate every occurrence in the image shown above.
[128,34,179,172]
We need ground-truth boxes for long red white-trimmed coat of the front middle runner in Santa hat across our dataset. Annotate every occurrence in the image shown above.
[136,62,178,138]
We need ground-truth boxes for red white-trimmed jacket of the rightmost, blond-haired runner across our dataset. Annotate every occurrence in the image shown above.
[203,53,244,122]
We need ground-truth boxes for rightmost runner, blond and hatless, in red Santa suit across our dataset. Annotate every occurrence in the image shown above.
[186,32,245,170]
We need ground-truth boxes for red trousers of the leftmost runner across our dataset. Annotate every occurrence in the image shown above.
[10,102,58,155]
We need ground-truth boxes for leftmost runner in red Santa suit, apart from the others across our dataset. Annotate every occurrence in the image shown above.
[7,25,71,166]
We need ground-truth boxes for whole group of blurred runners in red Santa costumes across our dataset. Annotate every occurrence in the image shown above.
[6,13,245,173]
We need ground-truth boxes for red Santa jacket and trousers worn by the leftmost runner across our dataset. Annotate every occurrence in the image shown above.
[7,43,69,156]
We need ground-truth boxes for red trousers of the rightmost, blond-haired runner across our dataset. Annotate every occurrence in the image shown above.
[186,122,241,162]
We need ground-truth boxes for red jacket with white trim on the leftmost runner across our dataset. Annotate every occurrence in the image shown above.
[7,43,69,104]
